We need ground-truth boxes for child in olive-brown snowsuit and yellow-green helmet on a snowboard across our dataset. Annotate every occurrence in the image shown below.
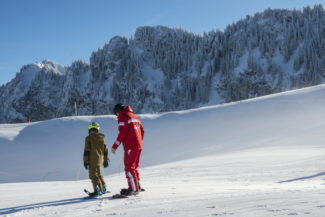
[83,122,109,196]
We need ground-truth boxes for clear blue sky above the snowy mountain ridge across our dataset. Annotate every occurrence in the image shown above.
[0,0,323,85]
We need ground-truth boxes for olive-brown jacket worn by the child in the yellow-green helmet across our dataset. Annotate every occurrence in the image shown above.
[83,132,108,166]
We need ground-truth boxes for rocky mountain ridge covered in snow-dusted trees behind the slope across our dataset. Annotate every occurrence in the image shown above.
[0,5,325,123]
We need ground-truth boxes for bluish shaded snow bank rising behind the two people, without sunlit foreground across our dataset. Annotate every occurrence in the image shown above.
[0,85,325,182]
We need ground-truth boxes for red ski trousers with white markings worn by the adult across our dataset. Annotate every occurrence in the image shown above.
[124,149,141,191]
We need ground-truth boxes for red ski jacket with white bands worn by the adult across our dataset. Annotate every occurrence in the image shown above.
[112,106,144,151]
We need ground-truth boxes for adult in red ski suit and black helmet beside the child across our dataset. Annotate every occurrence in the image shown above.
[112,104,144,196]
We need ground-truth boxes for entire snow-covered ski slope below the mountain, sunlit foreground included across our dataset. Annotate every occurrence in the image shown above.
[0,85,325,217]
